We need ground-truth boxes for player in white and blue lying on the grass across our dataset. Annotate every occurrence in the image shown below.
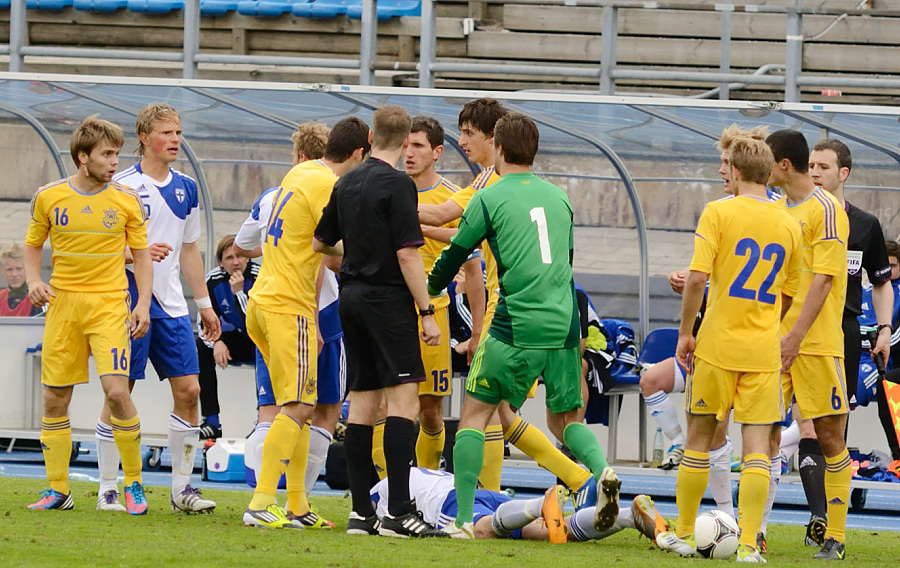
[371,468,666,542]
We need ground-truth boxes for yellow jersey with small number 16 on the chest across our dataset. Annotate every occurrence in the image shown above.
[25,179,147,292]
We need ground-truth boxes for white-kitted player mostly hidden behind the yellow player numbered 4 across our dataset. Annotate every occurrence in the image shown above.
[234,122,368,506]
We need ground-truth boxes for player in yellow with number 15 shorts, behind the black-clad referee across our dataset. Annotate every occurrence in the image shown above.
[404,116,483,469]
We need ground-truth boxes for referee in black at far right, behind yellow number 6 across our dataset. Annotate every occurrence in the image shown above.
[799,138,894,545]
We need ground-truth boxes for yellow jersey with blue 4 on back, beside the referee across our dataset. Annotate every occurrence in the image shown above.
[250,160,337,318]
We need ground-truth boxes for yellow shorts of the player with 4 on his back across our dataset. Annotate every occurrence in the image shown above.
[247,298,318,406]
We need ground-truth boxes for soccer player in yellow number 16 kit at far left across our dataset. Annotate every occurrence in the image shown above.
[25,117,153,515]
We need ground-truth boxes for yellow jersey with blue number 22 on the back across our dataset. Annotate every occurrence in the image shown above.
[690,196,803,372]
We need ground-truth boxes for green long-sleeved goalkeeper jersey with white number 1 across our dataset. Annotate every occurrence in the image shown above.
[428,173,579,349]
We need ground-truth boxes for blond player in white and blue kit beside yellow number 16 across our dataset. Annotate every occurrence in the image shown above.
[96,103,221,513]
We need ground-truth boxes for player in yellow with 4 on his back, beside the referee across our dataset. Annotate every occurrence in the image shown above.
[243,119,369,528]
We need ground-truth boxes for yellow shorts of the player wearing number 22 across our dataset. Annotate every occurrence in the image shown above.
[684,357,784,424]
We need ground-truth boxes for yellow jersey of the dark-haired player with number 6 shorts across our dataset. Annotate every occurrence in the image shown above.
[778,187,850,357]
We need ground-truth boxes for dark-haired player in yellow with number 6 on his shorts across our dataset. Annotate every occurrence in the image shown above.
[766,130,853,559]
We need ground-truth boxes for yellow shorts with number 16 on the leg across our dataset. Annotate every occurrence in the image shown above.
[41,290,131,387]
